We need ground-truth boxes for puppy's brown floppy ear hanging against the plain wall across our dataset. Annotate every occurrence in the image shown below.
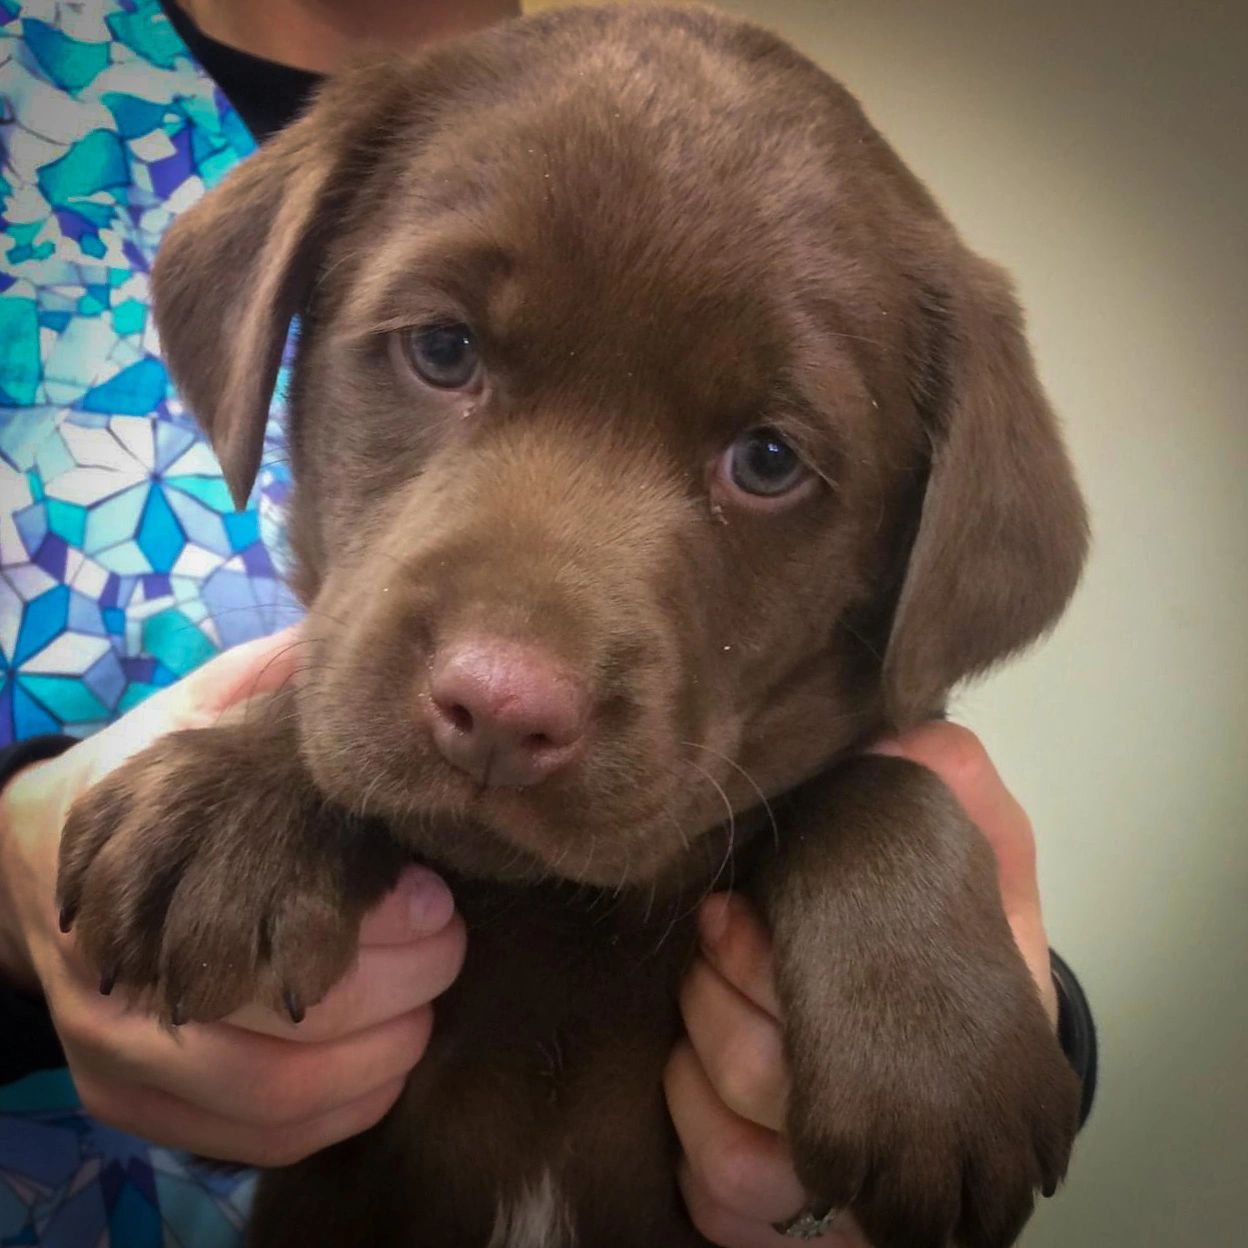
[884,252,1088,728]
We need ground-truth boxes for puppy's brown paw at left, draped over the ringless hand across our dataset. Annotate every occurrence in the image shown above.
[57,728,399,1023]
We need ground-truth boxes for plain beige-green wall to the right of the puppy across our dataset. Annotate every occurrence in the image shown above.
[521,0,1248,1248]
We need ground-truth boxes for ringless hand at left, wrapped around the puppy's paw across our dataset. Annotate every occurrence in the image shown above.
[0,631,464,1166]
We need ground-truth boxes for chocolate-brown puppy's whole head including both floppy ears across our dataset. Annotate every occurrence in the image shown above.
[155,10,1086,884]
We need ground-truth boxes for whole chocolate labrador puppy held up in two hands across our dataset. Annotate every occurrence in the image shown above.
[60,9,1086,1248]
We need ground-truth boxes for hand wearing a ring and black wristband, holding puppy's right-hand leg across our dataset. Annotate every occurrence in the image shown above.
[665,723,1057,1248]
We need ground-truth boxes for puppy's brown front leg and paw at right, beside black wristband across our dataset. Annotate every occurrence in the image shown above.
[760,756,1078,1248]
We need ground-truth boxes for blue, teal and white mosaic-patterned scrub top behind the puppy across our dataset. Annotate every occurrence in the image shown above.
[0,0,297,1248]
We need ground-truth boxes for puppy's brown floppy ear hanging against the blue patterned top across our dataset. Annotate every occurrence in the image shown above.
[152,61,411,508]
